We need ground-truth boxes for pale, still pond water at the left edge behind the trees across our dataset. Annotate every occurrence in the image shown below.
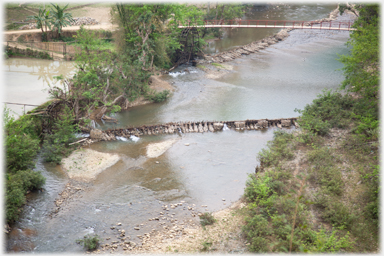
[1,58,75,115]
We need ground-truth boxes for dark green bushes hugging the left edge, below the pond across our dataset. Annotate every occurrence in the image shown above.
[3,108,45,223]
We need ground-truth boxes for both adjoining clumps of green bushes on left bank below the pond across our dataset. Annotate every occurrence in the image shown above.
[3,104,77,223]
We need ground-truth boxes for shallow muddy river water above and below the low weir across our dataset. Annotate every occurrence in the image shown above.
[3,5,356,253]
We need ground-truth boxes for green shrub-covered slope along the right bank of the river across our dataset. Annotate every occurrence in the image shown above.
[243,5,380,253]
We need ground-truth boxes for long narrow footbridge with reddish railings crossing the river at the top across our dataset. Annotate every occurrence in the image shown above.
[178,19,356,31]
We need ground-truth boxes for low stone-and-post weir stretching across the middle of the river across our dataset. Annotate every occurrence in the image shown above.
[83,117,299,144]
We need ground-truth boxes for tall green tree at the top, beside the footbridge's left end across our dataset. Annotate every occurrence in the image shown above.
[113,3,203,70]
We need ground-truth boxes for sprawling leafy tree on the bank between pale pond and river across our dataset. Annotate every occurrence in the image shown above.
[50,27,150,119]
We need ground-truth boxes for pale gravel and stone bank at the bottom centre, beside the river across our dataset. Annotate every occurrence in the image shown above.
[96,201,247,254]
